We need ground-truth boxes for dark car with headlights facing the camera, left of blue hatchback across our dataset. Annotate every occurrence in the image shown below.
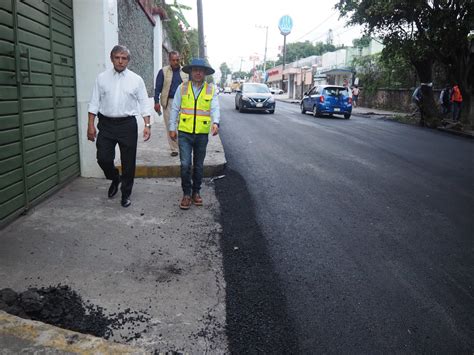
[235,83,275,113]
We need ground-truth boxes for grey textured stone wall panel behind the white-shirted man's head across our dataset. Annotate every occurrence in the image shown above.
[117,0,155,96]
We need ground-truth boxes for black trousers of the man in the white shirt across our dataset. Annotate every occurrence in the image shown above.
[96,114,138,197]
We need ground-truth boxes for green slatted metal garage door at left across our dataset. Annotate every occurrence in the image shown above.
[0,0,79,225]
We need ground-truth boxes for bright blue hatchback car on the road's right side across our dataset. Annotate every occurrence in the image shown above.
[300,85,352,119]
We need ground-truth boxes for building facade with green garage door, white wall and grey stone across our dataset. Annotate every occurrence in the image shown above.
[0,0,167,226]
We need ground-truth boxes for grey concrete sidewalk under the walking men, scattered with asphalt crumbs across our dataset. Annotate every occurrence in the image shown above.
[0,100,228,354]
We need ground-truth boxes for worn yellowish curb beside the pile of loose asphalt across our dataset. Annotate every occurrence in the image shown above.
[0,311,147,355]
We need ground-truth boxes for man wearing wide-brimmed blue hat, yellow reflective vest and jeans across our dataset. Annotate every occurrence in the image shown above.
[169,58,220,210]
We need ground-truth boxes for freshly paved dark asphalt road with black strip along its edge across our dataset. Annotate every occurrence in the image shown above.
[216,95,474,354]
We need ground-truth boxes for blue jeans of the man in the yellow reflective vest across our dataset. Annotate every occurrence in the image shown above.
[178,131,209,196]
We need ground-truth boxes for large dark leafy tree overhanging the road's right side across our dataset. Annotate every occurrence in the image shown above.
[336,0,474,126]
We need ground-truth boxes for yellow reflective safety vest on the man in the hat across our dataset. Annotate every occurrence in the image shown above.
[178,81,214,134]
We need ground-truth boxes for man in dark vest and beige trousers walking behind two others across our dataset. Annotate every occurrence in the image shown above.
[155,51,188,157]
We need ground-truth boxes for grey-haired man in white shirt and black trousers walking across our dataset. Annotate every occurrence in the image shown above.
[87,45,151,207]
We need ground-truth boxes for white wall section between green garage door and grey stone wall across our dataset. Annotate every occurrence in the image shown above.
[73,0,118,177]
